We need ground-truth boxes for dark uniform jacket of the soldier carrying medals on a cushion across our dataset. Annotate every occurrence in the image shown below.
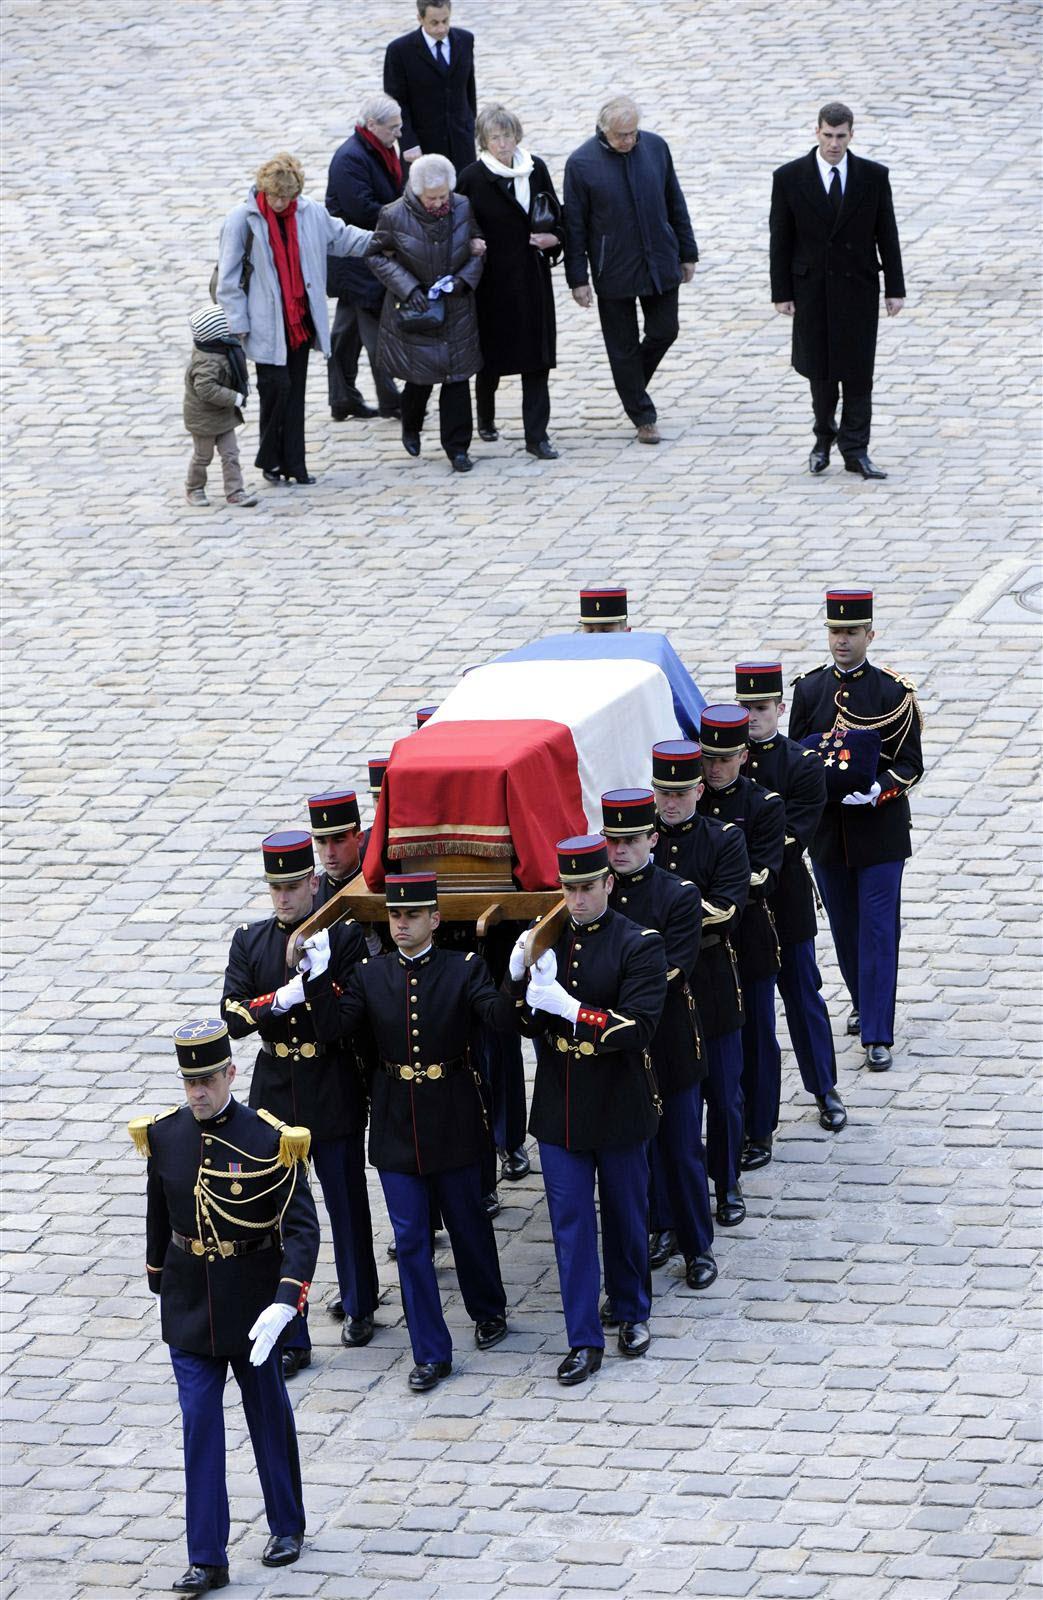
[789,661,923,867]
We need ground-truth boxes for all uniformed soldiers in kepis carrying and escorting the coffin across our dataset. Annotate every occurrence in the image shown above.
[130,586,923,1595]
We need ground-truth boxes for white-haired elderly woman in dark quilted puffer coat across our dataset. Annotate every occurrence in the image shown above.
[368,155,485,472]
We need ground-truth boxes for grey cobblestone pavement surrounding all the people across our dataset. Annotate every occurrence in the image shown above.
[2,0,1040,1600]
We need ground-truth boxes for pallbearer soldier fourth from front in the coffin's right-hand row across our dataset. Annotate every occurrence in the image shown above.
[699,706,785,1187]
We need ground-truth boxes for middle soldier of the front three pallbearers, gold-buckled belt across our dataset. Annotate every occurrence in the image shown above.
[302,872,515,1394]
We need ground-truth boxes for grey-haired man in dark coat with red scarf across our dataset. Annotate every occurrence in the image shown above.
[326,93,403,422]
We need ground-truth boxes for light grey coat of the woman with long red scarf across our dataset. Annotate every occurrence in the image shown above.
[218,189,373,366]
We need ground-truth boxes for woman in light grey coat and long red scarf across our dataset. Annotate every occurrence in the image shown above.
[218,154,373,483]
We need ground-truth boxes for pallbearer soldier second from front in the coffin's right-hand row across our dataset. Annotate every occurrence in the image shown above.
[601,789,717,1292]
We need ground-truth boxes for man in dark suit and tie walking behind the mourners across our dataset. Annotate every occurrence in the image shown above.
[384,0,478,173]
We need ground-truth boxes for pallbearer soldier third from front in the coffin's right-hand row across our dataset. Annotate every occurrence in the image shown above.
[653,739,750,1227]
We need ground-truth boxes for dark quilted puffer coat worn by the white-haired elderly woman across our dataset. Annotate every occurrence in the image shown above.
[370,190,485,384]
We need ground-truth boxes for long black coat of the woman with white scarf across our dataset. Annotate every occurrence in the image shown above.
[456,155,565,374]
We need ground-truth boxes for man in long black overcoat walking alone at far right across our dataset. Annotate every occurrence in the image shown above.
[769,101,905,478]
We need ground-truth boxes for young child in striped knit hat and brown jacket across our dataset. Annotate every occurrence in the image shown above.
[184,302,258,506]
